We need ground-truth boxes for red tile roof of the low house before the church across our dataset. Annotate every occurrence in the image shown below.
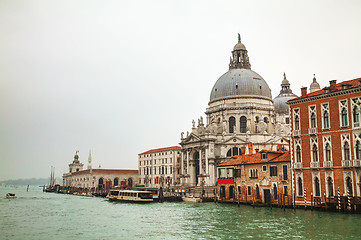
[217,150,291,167]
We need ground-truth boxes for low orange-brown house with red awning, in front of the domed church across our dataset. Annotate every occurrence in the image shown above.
[217,150,292,205]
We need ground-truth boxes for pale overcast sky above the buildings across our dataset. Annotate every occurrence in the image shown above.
[0,0,361,180]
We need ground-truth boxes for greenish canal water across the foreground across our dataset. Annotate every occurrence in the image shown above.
[0,186,361,239]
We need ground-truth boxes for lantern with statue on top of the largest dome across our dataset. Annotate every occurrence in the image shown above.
[229,33,251,69]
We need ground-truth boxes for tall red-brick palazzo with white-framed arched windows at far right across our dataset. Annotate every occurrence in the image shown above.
[287,78,361,208]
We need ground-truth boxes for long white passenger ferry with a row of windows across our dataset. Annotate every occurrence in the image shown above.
[107,189,153,203]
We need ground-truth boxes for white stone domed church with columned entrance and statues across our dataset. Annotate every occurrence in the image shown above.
[180,36,297,187]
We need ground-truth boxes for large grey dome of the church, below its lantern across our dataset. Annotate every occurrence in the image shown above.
[210,68,272,102]
